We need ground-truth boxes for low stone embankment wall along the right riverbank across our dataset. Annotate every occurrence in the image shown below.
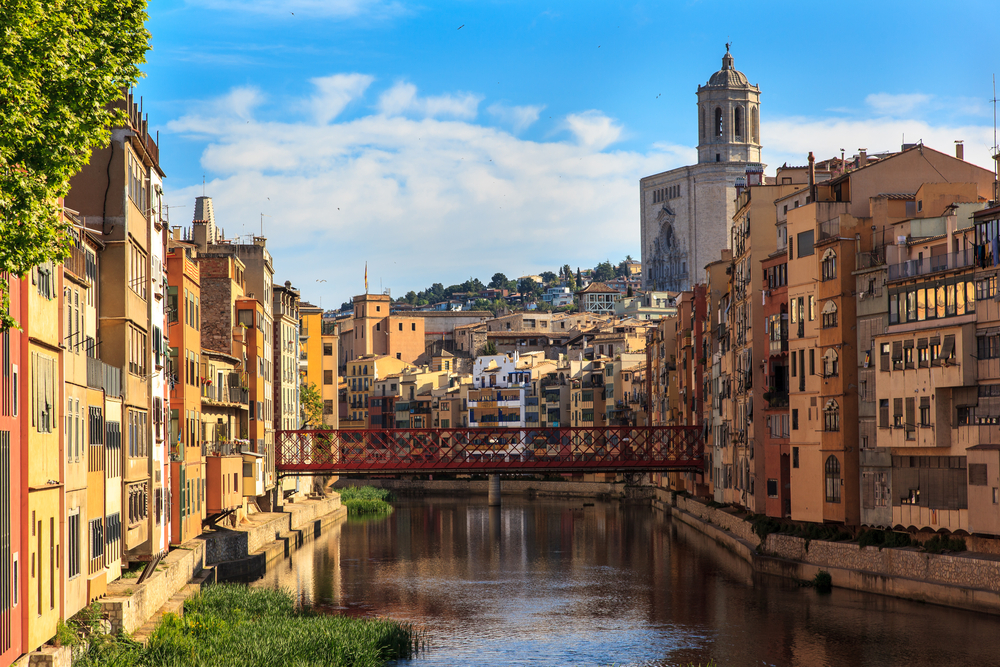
[654,491,1000,614]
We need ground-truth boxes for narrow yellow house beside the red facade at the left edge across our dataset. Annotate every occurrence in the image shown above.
[18,262,65,652]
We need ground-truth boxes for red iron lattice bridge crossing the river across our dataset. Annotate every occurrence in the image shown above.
[275,426,705,476]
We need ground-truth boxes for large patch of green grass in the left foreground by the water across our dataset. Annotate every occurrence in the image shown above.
[74,584,419,667]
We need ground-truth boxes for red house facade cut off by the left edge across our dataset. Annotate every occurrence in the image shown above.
[0,275,29,667]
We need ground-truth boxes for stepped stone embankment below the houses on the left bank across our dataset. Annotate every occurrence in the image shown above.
[99,495,347,639]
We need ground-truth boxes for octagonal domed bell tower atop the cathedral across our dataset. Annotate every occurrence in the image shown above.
[698,44,760,163]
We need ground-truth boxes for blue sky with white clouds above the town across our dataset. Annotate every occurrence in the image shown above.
[136,0,1000,309]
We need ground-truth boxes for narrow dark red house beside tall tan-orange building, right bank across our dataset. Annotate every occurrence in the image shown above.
[762,253,792,517]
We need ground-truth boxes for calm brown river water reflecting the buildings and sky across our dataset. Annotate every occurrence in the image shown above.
[248,497,1000,667]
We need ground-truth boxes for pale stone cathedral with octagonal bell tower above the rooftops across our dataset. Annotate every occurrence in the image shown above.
[639,44,762,292]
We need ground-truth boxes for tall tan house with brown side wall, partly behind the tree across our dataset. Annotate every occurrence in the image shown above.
[66,92,163,561]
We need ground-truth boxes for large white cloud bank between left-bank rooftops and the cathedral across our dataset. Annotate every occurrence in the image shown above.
[167,79,691,306]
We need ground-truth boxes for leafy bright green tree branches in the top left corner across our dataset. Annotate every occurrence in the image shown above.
[0,0,149,330]
